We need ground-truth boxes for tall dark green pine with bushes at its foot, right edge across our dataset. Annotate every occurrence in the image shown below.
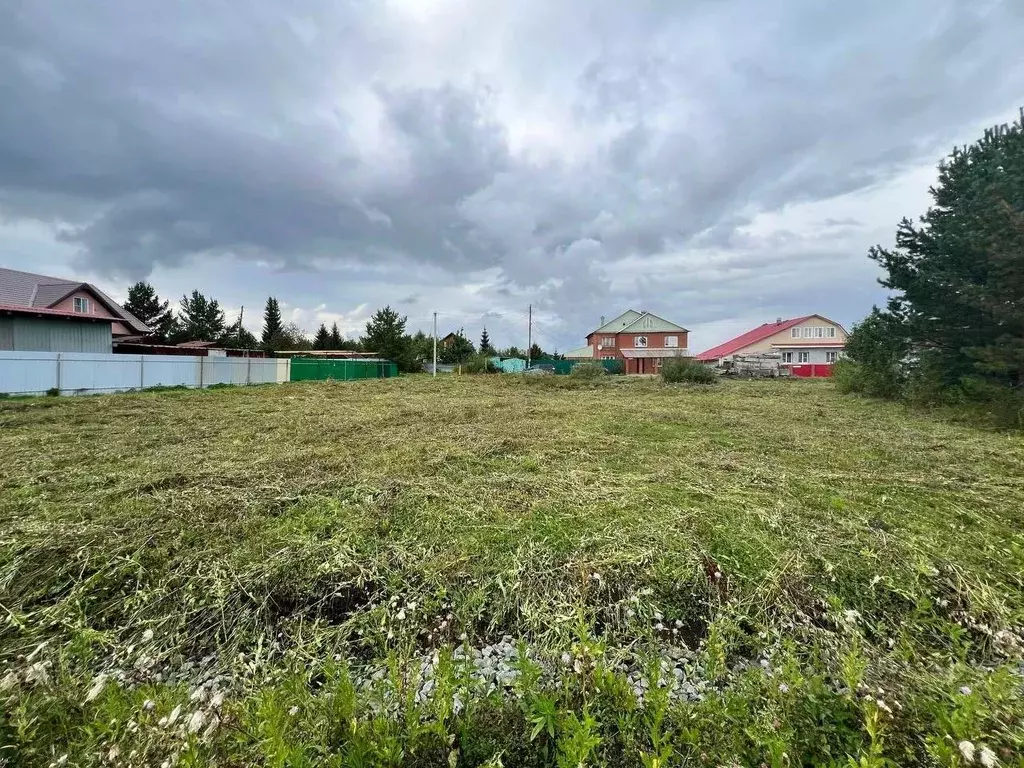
[836,110,1024,427]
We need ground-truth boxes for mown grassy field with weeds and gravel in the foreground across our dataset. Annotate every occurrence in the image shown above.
[0,377,1024,768]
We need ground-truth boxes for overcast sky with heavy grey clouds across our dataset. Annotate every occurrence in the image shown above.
[0,0,1024,351]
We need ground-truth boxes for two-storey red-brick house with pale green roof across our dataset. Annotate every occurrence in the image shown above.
[565,309,689,374]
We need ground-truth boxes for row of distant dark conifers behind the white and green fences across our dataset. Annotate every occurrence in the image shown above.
[124,281,551,372]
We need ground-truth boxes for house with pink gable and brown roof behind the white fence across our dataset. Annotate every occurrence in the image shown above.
[0,267,150,352]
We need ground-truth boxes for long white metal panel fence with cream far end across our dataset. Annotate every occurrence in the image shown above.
[0,351,291,394]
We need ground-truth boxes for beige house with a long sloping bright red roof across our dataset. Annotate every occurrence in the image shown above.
[696,314,847,376]
